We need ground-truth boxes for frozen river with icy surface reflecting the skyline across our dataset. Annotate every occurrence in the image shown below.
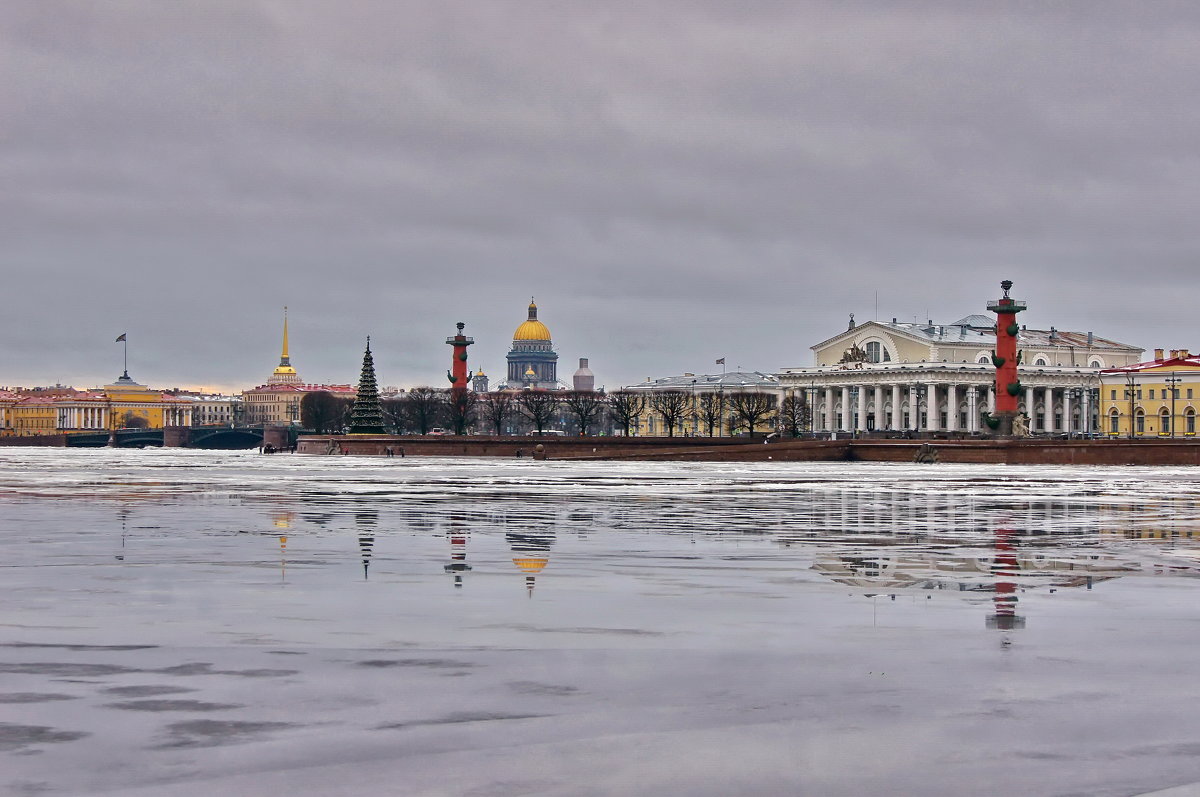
[0,448,1200,797]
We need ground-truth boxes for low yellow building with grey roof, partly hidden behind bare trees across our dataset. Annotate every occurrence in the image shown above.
[622,371,780,437]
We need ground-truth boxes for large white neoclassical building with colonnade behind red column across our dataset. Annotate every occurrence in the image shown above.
[779,314,1142,435]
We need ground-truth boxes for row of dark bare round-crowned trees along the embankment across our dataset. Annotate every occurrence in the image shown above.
[300,386,811,437]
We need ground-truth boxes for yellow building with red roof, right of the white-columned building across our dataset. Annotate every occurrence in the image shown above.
[1100,349,1200,438]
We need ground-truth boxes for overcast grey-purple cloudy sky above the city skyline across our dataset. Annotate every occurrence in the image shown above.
[0,0,1200,389]
